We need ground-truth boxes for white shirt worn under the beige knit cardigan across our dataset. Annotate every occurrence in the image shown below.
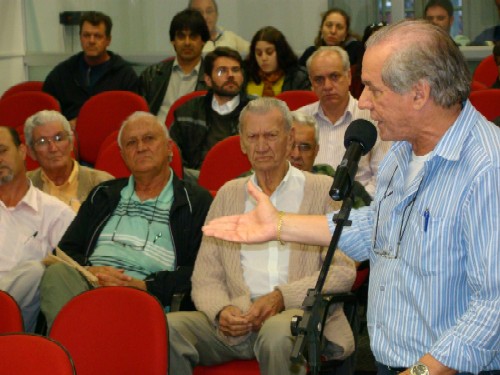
[241,165,306,299]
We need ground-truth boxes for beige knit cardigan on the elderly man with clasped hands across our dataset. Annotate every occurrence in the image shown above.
[192,172,356,358]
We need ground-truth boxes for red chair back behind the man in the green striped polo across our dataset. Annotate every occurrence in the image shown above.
[95,135,184,179]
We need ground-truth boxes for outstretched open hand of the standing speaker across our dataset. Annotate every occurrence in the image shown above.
[203,181,278,243]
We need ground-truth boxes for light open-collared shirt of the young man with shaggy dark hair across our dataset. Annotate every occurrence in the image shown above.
[156,58,202,124]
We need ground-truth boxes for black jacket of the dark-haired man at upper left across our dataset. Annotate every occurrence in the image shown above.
[42,51,139,120]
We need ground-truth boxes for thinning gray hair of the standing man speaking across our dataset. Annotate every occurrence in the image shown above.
[366,20,471,108]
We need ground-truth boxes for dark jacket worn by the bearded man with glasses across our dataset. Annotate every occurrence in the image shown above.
[170,91,253,169]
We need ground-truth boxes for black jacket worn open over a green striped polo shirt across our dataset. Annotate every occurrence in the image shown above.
[59,174,212,306]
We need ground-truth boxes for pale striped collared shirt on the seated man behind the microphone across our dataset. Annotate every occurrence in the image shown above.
[297,95,392,197]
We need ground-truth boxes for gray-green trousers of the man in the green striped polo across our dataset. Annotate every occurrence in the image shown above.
[40,263,92,330]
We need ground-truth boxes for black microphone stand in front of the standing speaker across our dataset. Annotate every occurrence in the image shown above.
[290,189,354,375]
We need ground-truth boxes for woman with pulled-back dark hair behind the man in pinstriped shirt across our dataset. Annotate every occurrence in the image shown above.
[299,8,365,66]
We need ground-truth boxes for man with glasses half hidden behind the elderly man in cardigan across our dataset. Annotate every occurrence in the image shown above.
[290,112,372,208]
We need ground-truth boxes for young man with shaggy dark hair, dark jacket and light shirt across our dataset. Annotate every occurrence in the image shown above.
[140,9,210,122]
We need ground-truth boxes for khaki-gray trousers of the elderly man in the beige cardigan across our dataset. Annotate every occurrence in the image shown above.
[167,309,306,375]
